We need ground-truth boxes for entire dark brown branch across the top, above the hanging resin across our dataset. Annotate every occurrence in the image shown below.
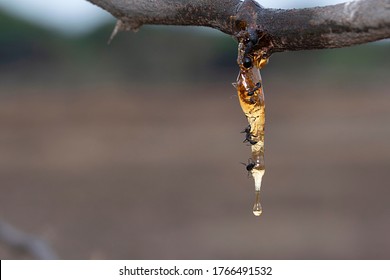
[88,0,390,53]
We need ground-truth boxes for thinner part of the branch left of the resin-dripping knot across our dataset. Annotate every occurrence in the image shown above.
[88,0,240,34]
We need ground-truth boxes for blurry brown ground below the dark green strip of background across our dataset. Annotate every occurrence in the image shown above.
[0,77,390,259]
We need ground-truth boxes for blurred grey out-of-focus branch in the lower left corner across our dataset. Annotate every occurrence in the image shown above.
[0,221,58,260]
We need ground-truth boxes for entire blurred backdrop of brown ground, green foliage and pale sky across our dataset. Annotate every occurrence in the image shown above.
[0,0,390,259]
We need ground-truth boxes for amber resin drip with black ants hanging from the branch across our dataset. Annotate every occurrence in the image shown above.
[233,38,268,216]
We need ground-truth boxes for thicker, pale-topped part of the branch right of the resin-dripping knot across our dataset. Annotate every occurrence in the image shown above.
[258,0,390,52]
